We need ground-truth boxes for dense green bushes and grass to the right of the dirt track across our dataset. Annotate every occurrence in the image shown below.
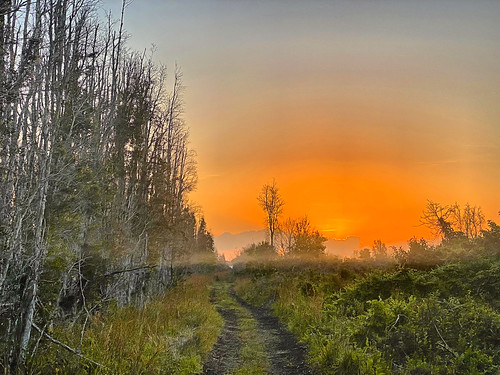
[236,259,500,374]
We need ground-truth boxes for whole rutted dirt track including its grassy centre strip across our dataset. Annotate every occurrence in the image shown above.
[203,281,311,375]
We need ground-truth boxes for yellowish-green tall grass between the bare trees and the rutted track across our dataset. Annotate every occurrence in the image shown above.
[30,276,223,374]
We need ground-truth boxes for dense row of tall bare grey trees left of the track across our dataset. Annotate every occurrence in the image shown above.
[0,0,215,373]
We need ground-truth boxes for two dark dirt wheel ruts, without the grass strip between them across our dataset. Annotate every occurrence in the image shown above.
[203,288,311,375]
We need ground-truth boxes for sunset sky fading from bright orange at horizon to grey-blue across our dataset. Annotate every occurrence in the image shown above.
[102,0,500,250]
